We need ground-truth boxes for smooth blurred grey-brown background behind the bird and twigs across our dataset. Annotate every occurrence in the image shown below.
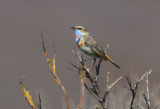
[0,0,160,109]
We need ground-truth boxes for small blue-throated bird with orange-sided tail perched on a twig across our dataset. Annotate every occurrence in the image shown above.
[71,26,120,68]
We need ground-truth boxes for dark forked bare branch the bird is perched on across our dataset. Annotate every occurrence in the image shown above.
[71,52,122,109]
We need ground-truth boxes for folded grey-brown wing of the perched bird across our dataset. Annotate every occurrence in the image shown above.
[84,36,105,58]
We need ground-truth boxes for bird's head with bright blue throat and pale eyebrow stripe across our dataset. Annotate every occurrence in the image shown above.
[71,26,89,42]
